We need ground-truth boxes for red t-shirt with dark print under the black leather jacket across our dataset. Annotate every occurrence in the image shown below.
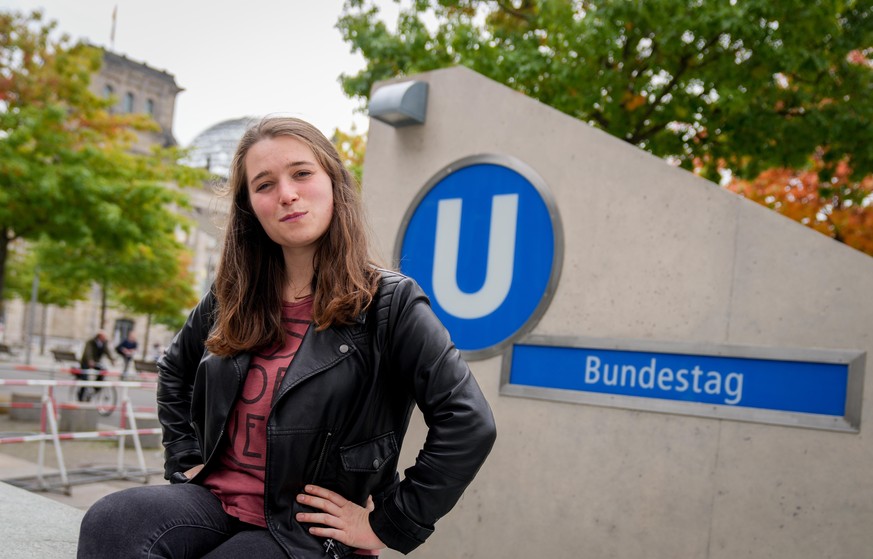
[204,296,312,528]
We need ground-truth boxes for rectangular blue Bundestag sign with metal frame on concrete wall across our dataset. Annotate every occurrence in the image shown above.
[502,340,864,430]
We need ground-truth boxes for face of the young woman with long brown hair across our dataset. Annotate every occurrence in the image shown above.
[245,136,333,256]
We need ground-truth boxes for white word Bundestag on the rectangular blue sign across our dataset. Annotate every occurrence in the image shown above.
[585,355,743,405]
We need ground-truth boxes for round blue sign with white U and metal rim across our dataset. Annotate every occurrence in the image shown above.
[396,155,563,359]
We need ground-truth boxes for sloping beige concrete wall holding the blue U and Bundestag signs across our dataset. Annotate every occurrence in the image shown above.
[364,68,873,559]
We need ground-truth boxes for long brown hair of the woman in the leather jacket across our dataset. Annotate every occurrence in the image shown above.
[206,117,378,356]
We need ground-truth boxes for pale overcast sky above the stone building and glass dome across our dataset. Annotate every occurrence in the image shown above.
[0,0,396,146]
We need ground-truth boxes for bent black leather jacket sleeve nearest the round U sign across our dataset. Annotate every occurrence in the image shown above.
[370,276,496,553]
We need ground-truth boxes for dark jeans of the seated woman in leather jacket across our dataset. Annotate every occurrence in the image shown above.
[78,484,286,559]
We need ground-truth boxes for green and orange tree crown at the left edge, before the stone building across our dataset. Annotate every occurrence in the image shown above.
[0,8,202,313]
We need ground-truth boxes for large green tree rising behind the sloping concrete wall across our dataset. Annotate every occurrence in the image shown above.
[337,0,873,187]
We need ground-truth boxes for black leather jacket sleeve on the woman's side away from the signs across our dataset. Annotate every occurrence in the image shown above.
[157,291,215,479]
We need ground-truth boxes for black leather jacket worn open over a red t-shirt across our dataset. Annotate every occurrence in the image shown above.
[158,272,496,558]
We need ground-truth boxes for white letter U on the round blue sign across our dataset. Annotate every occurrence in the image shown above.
[433,194,518,318]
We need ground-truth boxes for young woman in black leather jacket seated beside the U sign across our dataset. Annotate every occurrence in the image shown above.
[79,118,495,559]
